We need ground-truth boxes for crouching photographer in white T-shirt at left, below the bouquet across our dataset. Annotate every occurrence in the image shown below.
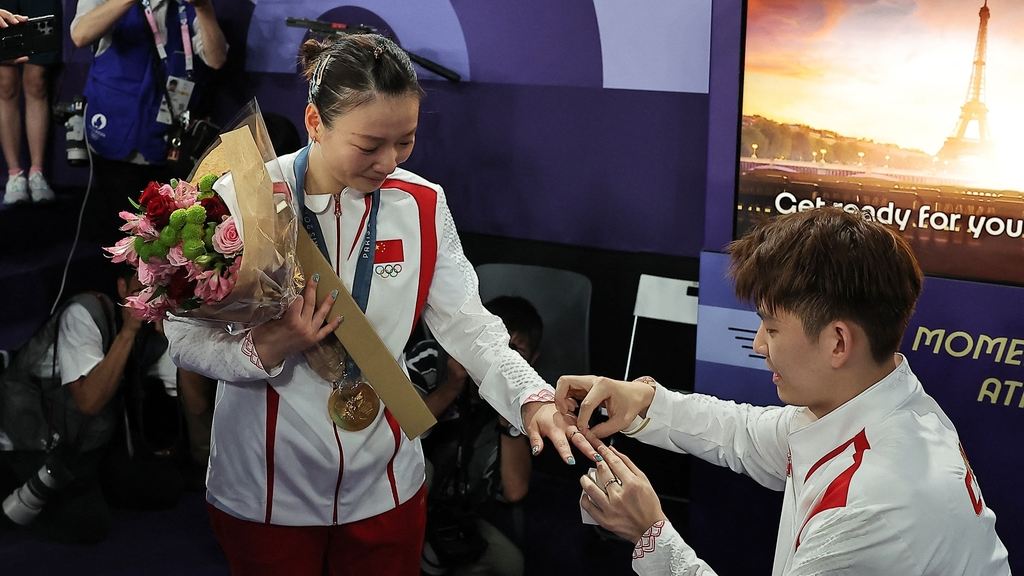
[0,265,185,544]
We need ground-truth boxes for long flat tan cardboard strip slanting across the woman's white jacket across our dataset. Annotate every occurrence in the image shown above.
[296,213,437,440]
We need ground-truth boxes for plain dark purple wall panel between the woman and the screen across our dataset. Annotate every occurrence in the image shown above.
[407,82,708,257]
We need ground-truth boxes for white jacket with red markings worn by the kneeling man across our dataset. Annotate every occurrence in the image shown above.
[633,357,1010,576]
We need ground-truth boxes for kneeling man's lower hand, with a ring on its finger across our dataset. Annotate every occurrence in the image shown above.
[580,446,667,542]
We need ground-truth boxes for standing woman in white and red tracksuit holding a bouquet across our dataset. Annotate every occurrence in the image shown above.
[166,35,593,576]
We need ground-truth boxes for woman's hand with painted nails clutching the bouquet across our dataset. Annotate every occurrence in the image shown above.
[252,275,342,369]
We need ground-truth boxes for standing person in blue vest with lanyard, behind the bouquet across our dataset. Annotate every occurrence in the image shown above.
[71,0,227,245]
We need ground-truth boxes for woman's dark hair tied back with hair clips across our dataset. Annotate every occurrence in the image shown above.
[299,34,424,128]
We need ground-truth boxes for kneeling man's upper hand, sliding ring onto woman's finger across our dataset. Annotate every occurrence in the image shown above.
[555,376,654,434]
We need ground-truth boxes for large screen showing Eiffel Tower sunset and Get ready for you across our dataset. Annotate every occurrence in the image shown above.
[733,0,1024,284]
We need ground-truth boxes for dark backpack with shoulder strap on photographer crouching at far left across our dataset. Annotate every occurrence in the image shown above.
[0,292,117,452]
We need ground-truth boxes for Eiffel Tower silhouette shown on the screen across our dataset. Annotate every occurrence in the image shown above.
[937,0,995,164]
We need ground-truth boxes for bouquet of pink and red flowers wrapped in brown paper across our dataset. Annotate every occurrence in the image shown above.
[104,101,302,329]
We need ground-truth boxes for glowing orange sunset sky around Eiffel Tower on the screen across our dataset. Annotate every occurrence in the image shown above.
[743,0,1024,165]
